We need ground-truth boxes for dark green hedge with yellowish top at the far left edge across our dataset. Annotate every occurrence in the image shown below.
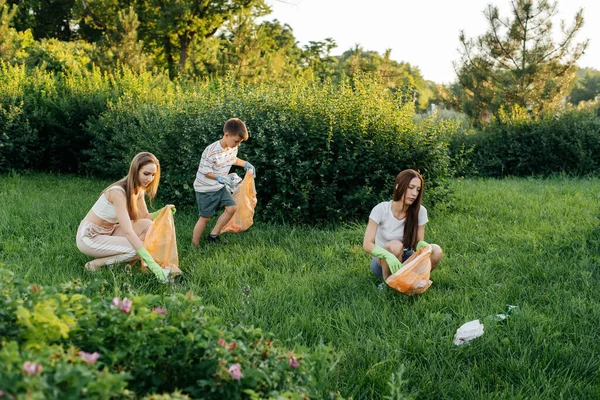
[0,64,113,172]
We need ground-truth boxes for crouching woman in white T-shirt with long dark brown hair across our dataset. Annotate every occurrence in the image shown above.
[363,169,442,279]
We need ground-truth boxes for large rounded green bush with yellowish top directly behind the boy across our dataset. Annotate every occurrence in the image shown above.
[87,78,456,222]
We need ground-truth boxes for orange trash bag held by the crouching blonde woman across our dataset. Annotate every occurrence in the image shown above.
[142,205,181,276]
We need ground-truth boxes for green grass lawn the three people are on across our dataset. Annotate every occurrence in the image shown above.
[0,175,600,399]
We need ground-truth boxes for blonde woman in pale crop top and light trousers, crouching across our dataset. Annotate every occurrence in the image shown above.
[77,153,174,283]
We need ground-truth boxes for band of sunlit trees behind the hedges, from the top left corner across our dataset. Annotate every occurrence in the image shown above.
[0,0,436,110]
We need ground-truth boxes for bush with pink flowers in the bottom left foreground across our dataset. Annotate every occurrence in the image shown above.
[0,268,337,399]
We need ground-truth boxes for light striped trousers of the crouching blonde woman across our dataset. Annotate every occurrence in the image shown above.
[77,219,152,265]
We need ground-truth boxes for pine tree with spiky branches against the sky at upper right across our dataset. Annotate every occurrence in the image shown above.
[454,0,588,119]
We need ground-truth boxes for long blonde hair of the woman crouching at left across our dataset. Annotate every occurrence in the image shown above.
[109,152,160,221]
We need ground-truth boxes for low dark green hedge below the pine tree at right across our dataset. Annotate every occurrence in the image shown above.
[451,104,600,177]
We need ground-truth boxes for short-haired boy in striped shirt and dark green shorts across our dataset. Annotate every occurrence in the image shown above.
[192,118,256,247]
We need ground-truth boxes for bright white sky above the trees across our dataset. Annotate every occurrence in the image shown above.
[265,0,600,83]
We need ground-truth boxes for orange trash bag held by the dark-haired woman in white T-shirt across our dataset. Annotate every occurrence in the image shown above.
[385,244,432,296]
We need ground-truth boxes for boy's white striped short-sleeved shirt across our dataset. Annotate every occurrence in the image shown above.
[194,140,238,193]
